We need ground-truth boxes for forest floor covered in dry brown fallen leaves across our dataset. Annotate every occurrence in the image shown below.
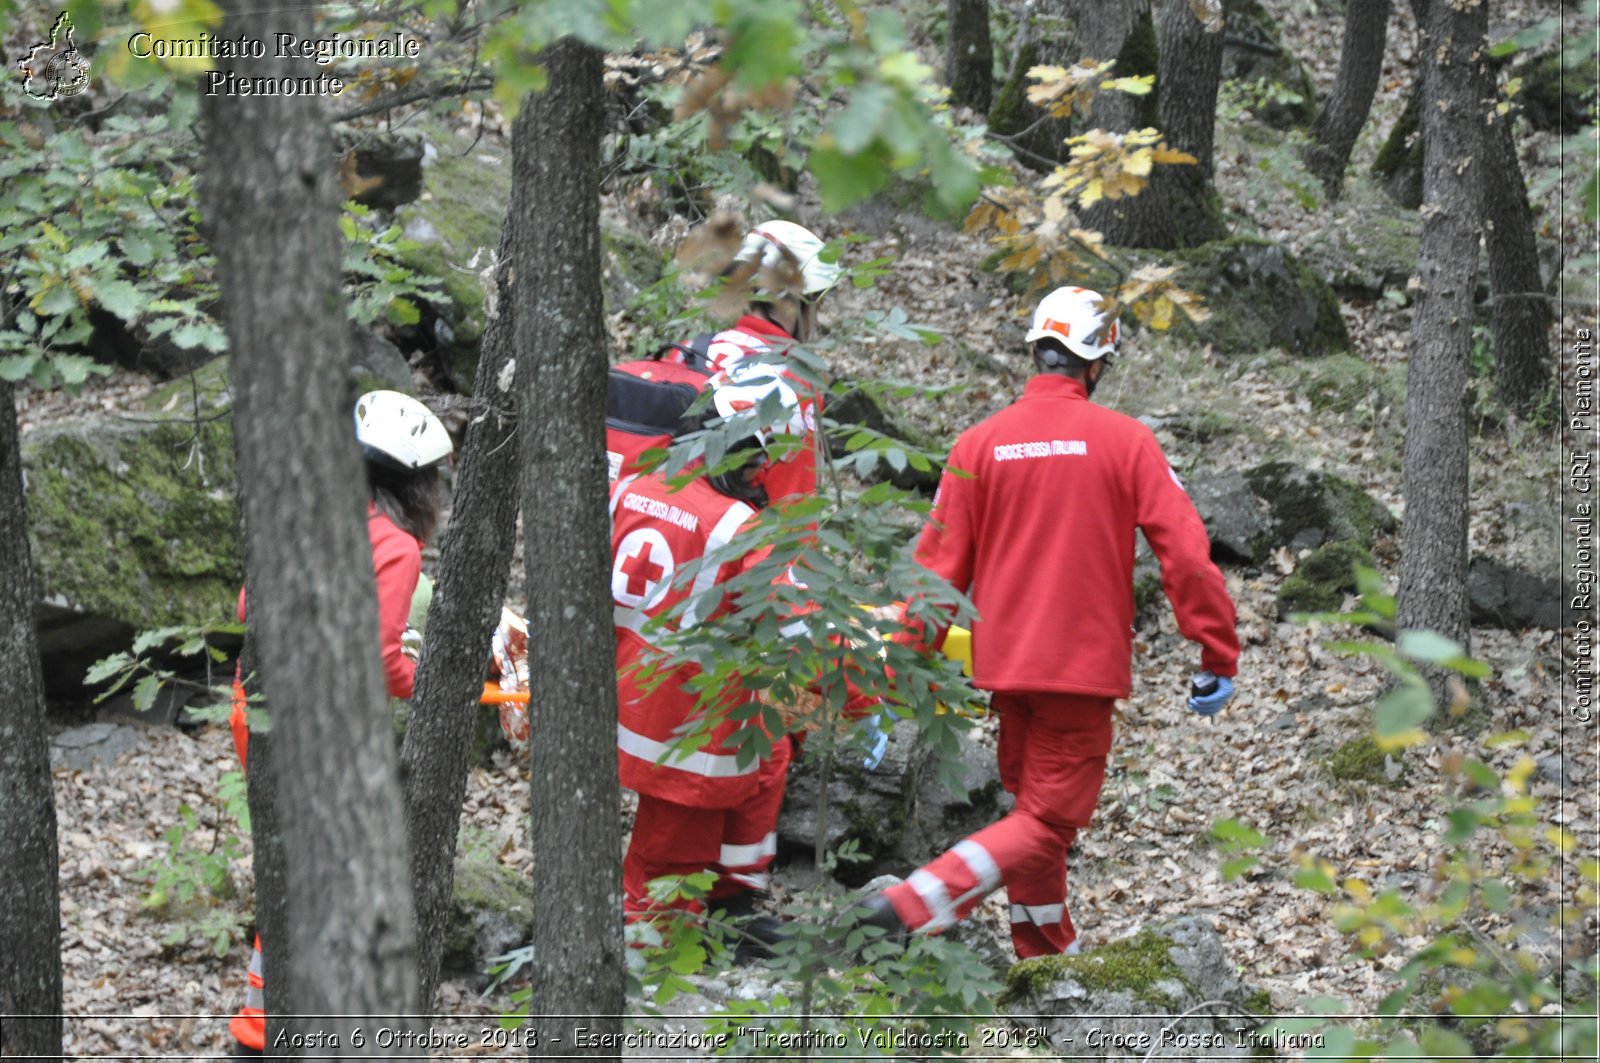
[31,3,1600,1058]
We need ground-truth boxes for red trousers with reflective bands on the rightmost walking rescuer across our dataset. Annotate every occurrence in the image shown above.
[885,693,1112,959]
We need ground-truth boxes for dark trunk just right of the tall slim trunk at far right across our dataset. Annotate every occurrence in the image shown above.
[1483,100,1550,416]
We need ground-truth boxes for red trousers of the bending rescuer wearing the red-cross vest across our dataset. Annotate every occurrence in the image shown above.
[622,738,794,921]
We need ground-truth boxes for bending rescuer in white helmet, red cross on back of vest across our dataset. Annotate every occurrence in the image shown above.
[611,365,805,956]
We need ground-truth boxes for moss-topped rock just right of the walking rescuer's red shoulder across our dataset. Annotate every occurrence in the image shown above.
[1245,461,1398,559]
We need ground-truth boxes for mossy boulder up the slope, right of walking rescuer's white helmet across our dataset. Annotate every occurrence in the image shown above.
[1173,237,1350,355]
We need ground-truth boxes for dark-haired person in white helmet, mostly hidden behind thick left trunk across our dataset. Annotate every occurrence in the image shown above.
[229,391,453,1057]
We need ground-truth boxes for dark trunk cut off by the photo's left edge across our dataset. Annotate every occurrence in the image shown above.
[0,377,61,1060]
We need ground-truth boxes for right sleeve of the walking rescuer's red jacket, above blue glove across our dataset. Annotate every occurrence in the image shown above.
[1133,435,1238,676]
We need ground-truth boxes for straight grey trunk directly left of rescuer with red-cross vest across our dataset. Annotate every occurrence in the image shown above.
[510,38,626,1058]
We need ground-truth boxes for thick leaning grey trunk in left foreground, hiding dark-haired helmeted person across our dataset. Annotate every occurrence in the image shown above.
[205,0,418,1057]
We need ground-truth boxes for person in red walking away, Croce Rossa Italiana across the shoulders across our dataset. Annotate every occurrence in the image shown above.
[866,288,1238,959]
